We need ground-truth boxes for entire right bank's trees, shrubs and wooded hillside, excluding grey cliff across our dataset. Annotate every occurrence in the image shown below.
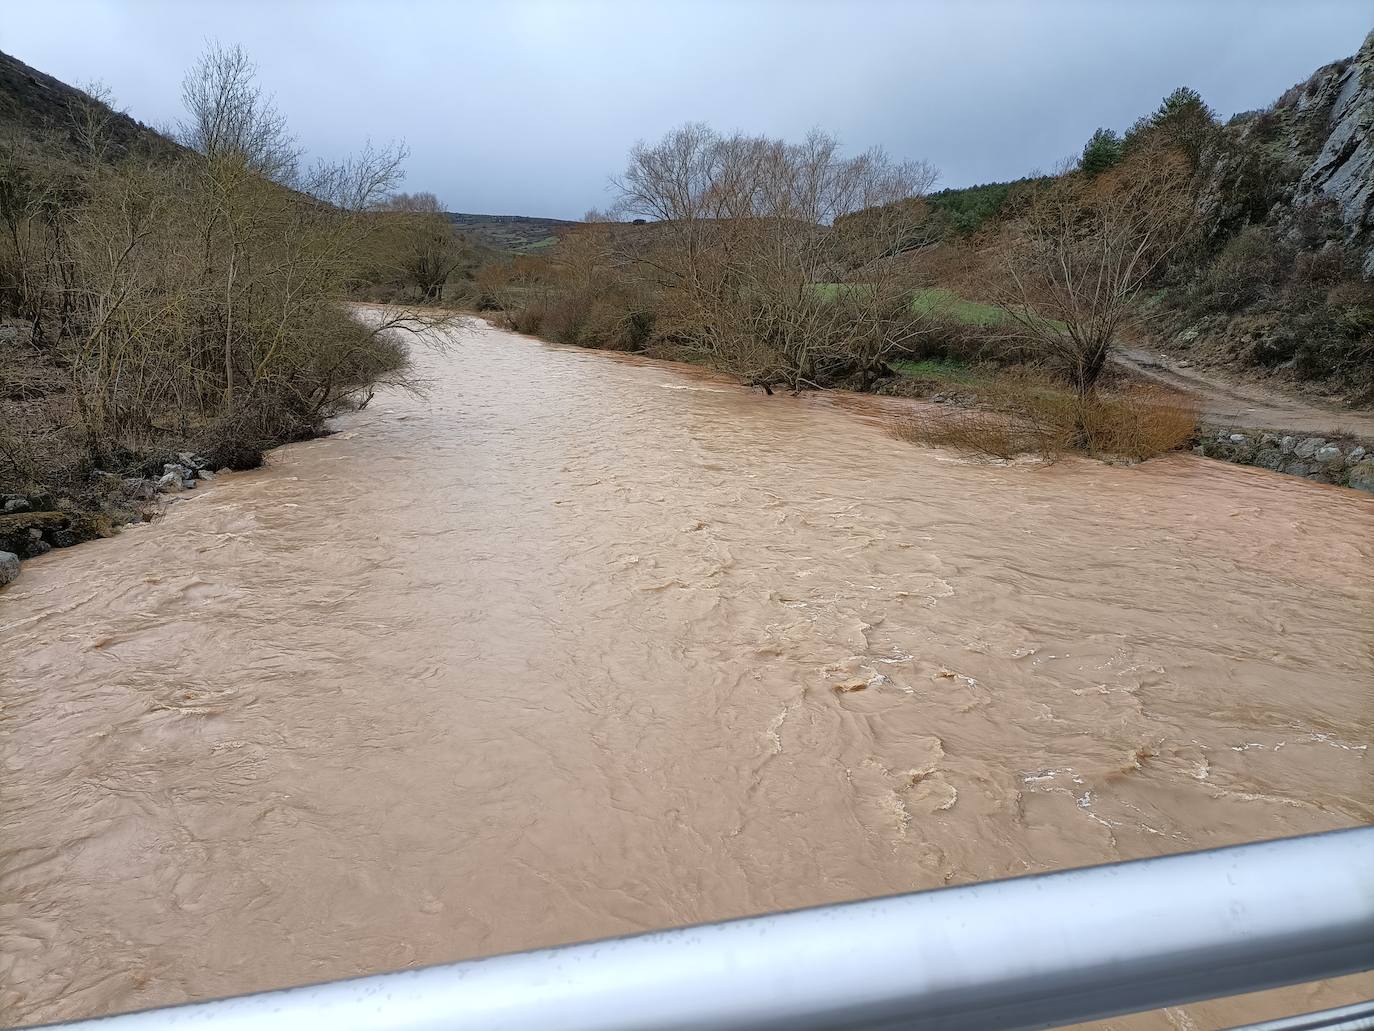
[486,44,1374,458]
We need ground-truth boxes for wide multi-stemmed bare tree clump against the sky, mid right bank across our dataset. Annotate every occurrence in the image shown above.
[616,124,936,389]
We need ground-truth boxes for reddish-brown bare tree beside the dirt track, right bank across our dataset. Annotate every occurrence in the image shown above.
[998,148,1193,397]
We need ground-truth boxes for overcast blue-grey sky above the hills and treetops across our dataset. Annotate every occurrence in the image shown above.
[0,0,1374,217]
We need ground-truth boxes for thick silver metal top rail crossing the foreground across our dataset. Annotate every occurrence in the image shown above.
[32,828,1374,1031]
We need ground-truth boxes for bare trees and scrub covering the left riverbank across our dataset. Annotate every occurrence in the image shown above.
[0,47,456,549]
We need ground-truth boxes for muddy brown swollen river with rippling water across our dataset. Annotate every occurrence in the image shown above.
[0,318,1374,1031]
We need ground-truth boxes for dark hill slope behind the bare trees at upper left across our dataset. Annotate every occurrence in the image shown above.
[0,54,180,158]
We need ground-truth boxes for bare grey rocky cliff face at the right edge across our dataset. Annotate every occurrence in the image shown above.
[1279,32,1374,279]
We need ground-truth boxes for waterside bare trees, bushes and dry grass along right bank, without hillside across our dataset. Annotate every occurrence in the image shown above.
[481,112,1193,458]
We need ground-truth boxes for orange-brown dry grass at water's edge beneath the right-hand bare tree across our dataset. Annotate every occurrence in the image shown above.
[892,377,1197,462]
